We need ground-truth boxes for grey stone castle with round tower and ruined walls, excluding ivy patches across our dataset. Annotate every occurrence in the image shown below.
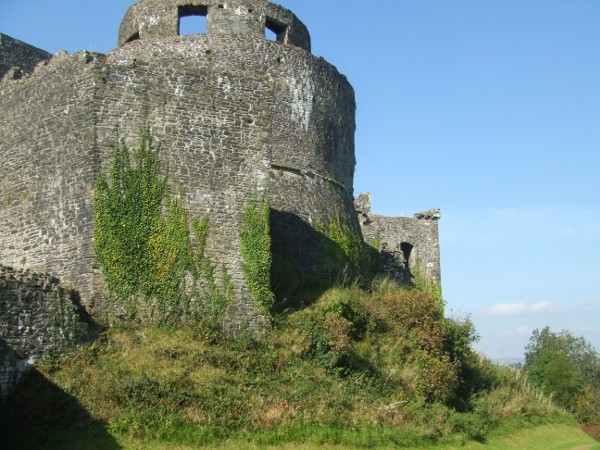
[0,0,440,394]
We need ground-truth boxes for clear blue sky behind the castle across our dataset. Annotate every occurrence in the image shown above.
[0,0,600,358]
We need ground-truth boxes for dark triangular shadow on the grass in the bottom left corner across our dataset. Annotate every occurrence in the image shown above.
[0,338,122,450]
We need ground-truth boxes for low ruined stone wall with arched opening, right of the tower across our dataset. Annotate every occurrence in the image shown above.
[355,193,441,287]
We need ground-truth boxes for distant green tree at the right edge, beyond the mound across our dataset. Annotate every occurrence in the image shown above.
[524,327,600,422]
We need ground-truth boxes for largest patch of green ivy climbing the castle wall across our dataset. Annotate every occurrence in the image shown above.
[94,129,233,324]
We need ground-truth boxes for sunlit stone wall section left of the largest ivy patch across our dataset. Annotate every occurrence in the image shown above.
[0,52,102,310]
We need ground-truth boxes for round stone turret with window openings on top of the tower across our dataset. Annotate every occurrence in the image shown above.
[119,0,310,52]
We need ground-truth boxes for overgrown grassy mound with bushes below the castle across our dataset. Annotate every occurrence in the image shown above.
[0,283,577,449]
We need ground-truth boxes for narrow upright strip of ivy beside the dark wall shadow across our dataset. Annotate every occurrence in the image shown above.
[240,199,274,312]
